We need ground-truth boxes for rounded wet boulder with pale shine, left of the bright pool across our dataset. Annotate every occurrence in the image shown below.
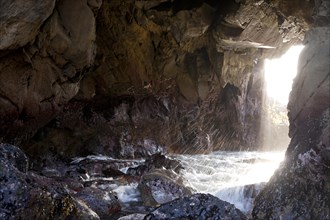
[138,170,191,206]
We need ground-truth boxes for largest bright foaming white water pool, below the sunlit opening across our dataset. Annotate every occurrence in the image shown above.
[173,152,284,213]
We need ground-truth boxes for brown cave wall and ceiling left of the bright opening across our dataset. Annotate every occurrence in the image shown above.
[0,0,312,158]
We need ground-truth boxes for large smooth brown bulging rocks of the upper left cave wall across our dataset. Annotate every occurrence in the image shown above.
[0,0,96,143]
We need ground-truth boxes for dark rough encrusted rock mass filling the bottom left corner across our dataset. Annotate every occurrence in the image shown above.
[0,144,99,220]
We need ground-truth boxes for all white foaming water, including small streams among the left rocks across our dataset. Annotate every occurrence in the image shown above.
[72,151,284,214]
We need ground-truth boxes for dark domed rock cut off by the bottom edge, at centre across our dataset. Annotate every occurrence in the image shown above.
[145,194,247,220]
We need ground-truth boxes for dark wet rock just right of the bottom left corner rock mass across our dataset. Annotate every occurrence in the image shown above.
[75,187,121,219]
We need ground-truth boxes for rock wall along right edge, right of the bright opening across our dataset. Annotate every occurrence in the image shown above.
[253,1,330,219]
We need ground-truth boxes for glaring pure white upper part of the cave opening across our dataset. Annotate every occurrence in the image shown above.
[265,46,304,105]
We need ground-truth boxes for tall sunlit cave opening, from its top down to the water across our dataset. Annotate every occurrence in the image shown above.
[260,45,304,150]
